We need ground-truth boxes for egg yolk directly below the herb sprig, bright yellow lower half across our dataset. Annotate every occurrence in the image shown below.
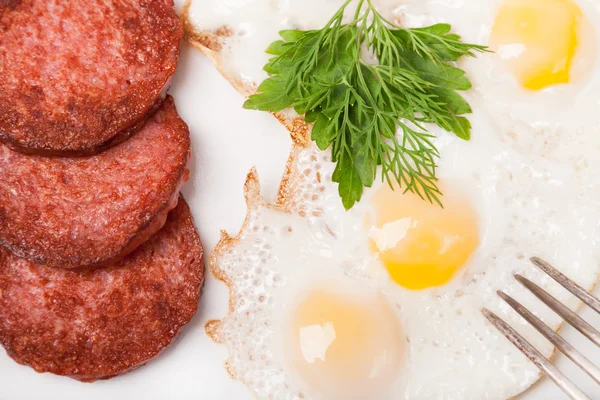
[367,185,479,290]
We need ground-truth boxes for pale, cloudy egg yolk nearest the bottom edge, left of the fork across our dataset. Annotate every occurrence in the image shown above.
[286,290,404,399]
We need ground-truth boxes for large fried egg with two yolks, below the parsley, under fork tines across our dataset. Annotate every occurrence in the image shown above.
[207,114,600,400]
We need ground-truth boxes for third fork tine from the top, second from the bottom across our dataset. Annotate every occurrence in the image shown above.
[498,291,600,383]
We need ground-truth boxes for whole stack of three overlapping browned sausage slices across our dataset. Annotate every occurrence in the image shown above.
[0,0,204,381]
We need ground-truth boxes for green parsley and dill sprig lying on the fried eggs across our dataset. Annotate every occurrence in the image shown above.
[244,0,486,209]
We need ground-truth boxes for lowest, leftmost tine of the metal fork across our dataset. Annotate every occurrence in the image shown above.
[481,308,591,400]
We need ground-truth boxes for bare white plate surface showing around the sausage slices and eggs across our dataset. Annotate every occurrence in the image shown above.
[0,6,600,400]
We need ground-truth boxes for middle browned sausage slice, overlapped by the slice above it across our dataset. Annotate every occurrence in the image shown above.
[0,97,190,268]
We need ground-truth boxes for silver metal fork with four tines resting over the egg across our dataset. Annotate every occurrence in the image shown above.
[481,257,600,400]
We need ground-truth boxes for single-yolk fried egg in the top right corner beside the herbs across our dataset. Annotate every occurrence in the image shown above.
[396,0,600,165]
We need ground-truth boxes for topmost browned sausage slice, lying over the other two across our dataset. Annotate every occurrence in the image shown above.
[0,0,183,155]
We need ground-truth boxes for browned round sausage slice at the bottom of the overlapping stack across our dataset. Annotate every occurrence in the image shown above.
[0,199,204,381]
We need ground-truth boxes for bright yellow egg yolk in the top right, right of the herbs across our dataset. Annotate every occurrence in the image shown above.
[490,0,583,90]
